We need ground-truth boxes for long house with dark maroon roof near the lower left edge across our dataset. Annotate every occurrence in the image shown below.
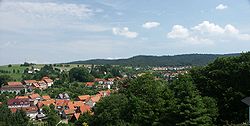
[7,98,30,108]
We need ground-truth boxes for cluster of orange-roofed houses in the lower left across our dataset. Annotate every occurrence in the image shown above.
[0,77,119,122]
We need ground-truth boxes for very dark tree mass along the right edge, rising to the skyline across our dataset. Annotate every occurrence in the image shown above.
[191,52,250,124]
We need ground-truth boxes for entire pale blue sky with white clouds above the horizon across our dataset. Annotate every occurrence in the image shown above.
[0,0,250,65]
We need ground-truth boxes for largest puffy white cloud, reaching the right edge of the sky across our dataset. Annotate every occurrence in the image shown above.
[167,21,250,44]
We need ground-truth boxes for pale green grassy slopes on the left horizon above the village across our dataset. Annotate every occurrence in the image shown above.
[0,64,89,81]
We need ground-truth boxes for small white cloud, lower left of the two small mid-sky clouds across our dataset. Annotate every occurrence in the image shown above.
[112,27,138,38]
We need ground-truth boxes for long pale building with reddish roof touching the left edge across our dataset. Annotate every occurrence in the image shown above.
[0,82,27,94]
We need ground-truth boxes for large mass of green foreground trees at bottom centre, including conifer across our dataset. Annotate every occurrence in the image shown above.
[90,74,217,126]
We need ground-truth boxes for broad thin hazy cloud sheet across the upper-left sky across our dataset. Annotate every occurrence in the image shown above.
[0,0,111,34]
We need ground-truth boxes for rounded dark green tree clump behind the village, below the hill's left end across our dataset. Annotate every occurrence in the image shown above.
[69,67,94,82]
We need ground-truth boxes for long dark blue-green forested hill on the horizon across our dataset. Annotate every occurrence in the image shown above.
[68,53,240,66]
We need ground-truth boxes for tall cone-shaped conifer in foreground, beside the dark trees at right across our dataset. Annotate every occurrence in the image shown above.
[171,77,217,126]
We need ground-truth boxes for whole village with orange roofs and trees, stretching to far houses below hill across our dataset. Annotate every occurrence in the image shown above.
[0,63,193,124]
